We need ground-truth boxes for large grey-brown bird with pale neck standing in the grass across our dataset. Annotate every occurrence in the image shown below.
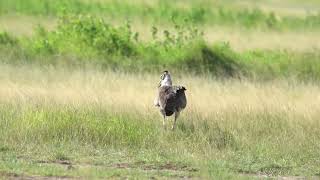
[154,70,187,130]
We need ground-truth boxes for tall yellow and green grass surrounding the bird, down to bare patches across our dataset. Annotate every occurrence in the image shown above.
[0,66,320,176]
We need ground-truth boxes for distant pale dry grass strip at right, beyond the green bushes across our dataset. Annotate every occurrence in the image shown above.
[204,27,320,52]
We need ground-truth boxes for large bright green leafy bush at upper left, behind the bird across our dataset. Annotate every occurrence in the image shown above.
[30,16,136,57]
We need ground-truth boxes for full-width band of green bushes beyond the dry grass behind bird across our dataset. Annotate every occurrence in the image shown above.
[0,16,320,80]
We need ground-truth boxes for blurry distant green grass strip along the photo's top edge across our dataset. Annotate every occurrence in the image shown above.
[0,0,320,30]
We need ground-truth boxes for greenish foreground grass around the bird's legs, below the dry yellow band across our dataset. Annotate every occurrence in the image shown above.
[0,100,320,177]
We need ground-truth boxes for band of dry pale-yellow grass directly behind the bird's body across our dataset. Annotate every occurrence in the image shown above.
[0,65,320,119]
